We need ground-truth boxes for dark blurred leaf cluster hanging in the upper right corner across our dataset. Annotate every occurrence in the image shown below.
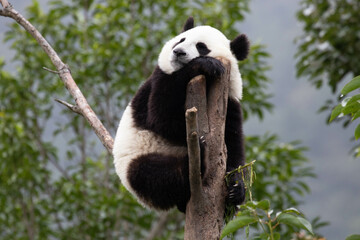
[296,0,360,135]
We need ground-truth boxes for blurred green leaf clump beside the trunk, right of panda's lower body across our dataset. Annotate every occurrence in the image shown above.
[246,134,315,211]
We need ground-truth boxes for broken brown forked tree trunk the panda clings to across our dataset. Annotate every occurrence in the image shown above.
[185,59,230,240]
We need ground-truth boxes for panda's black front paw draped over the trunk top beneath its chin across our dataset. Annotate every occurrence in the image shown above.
[189,56,225,79]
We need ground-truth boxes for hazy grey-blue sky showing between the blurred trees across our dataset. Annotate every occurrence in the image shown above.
[0,0,360,240]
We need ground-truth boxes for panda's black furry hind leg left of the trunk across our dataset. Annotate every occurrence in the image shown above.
[128,153,190,212]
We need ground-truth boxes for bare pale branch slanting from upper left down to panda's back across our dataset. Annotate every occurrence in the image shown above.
[0,0,114,153]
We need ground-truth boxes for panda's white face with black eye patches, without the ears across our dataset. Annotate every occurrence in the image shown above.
[158,26,236,74]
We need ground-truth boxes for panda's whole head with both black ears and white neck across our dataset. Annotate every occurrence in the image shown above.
[158,17,249,99]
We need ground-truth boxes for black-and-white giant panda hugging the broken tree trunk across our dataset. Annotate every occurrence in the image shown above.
[113,17,249,212]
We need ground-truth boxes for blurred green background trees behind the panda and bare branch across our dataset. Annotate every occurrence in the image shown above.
[0,0,312,239]
